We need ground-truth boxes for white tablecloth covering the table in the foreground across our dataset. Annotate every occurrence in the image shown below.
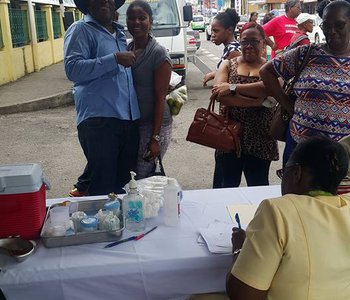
[0,186,280,300]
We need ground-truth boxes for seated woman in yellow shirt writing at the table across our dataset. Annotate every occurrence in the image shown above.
[226,137,350,300]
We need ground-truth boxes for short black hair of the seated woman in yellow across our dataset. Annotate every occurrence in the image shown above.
[288,136,349,194]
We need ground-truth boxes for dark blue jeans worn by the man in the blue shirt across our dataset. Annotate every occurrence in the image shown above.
[78,117,139,195]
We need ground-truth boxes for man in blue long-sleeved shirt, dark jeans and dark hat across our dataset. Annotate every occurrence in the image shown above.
[64,0,140,195]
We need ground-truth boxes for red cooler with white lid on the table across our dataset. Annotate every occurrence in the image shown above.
[0,164,46,239]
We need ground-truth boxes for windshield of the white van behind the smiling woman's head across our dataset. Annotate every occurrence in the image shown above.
[118,0,180,29]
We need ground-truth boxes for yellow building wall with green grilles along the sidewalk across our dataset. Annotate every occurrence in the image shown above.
[0,0,81,85]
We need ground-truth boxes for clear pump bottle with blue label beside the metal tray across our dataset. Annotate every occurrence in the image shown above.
[123,171,146,231]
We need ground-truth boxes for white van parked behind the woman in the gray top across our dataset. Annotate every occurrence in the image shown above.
[118,0,192,80]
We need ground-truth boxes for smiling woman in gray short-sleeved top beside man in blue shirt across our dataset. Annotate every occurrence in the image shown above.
[126,0,172,179]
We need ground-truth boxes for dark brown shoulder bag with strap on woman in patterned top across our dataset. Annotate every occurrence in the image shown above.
[270,45,312,142]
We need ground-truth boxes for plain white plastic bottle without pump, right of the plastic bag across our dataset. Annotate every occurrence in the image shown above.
[164,178,181,226]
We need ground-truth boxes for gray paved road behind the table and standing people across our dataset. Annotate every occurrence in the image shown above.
[0,35,280,198]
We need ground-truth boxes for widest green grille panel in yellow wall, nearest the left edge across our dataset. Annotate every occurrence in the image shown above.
[9,8,30,48]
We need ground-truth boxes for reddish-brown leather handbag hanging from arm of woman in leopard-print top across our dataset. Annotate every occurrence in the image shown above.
[186,99,242,157]
